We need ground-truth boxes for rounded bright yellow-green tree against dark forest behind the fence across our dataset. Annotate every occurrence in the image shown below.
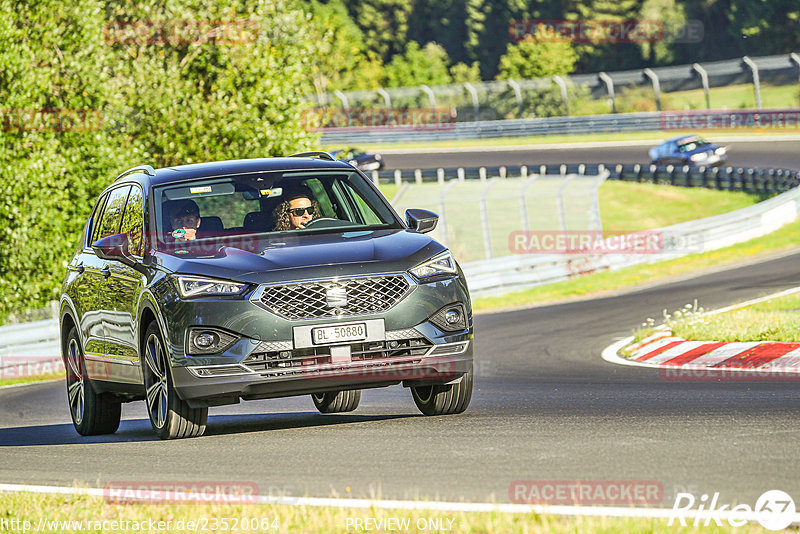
[497,37,578,80]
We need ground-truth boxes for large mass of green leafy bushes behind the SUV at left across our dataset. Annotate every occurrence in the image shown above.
[0,0,324,318]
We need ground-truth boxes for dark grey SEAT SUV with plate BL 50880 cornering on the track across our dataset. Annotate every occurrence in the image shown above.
[60,152,473,439]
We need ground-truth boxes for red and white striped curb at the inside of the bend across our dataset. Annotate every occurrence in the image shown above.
[603,288,800,380]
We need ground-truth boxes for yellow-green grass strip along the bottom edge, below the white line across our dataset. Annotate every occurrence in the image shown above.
[0,493,762,534]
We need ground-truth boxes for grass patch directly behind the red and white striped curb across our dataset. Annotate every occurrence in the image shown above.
[668,294,800,341]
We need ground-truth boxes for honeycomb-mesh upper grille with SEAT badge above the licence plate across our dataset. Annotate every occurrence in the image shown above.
[258,274,411,319]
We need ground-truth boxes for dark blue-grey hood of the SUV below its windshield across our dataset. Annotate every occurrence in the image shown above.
[155,229,444,284]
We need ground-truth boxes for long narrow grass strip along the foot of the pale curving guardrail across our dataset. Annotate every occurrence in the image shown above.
[473,220,800,311]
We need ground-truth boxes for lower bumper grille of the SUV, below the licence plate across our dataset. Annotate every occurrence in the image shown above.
[242,337,433,376]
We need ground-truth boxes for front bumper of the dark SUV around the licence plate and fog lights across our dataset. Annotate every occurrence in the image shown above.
[161,277,473,406]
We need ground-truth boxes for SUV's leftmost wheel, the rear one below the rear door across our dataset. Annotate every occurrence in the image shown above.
[65,328,122,436]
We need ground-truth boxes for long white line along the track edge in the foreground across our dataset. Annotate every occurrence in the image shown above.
[0,484,800,522]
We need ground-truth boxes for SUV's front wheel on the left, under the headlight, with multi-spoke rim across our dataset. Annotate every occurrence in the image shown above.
[142,321,208,439]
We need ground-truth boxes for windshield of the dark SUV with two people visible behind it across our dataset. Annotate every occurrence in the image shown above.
[154,171,402,254]
